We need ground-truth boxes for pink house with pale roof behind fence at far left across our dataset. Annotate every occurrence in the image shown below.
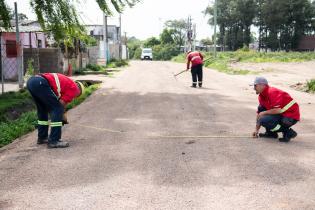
[0,21,46,81]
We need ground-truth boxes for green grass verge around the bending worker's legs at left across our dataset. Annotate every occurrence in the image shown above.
[0,84,100,147]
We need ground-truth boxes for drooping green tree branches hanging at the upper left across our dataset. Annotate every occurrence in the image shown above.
[0,0,139,42]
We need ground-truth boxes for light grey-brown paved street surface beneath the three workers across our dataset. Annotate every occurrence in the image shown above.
[0,61,315,210]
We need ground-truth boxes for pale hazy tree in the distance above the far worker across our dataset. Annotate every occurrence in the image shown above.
[165,19,187,47]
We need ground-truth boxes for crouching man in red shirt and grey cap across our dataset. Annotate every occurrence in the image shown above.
[253,77,300,142]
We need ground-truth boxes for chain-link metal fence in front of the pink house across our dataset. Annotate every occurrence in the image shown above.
[0,36,24,93]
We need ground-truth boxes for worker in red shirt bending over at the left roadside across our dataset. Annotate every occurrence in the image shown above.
[27,73,84,148]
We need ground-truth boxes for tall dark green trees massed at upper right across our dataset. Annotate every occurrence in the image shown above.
[205,0,315,50]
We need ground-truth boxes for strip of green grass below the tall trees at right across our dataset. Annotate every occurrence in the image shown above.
[172,50,315,74]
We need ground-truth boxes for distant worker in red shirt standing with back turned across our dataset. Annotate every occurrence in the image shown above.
[187,51,203,88]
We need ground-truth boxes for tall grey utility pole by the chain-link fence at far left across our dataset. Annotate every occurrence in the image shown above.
[14,2,24,88]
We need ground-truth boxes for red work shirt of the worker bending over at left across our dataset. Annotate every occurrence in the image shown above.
[40,73,80,103]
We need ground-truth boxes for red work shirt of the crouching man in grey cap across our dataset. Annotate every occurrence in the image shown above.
[258,86,300,121]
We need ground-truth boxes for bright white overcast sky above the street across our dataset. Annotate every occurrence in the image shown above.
[6,0,213,40]
